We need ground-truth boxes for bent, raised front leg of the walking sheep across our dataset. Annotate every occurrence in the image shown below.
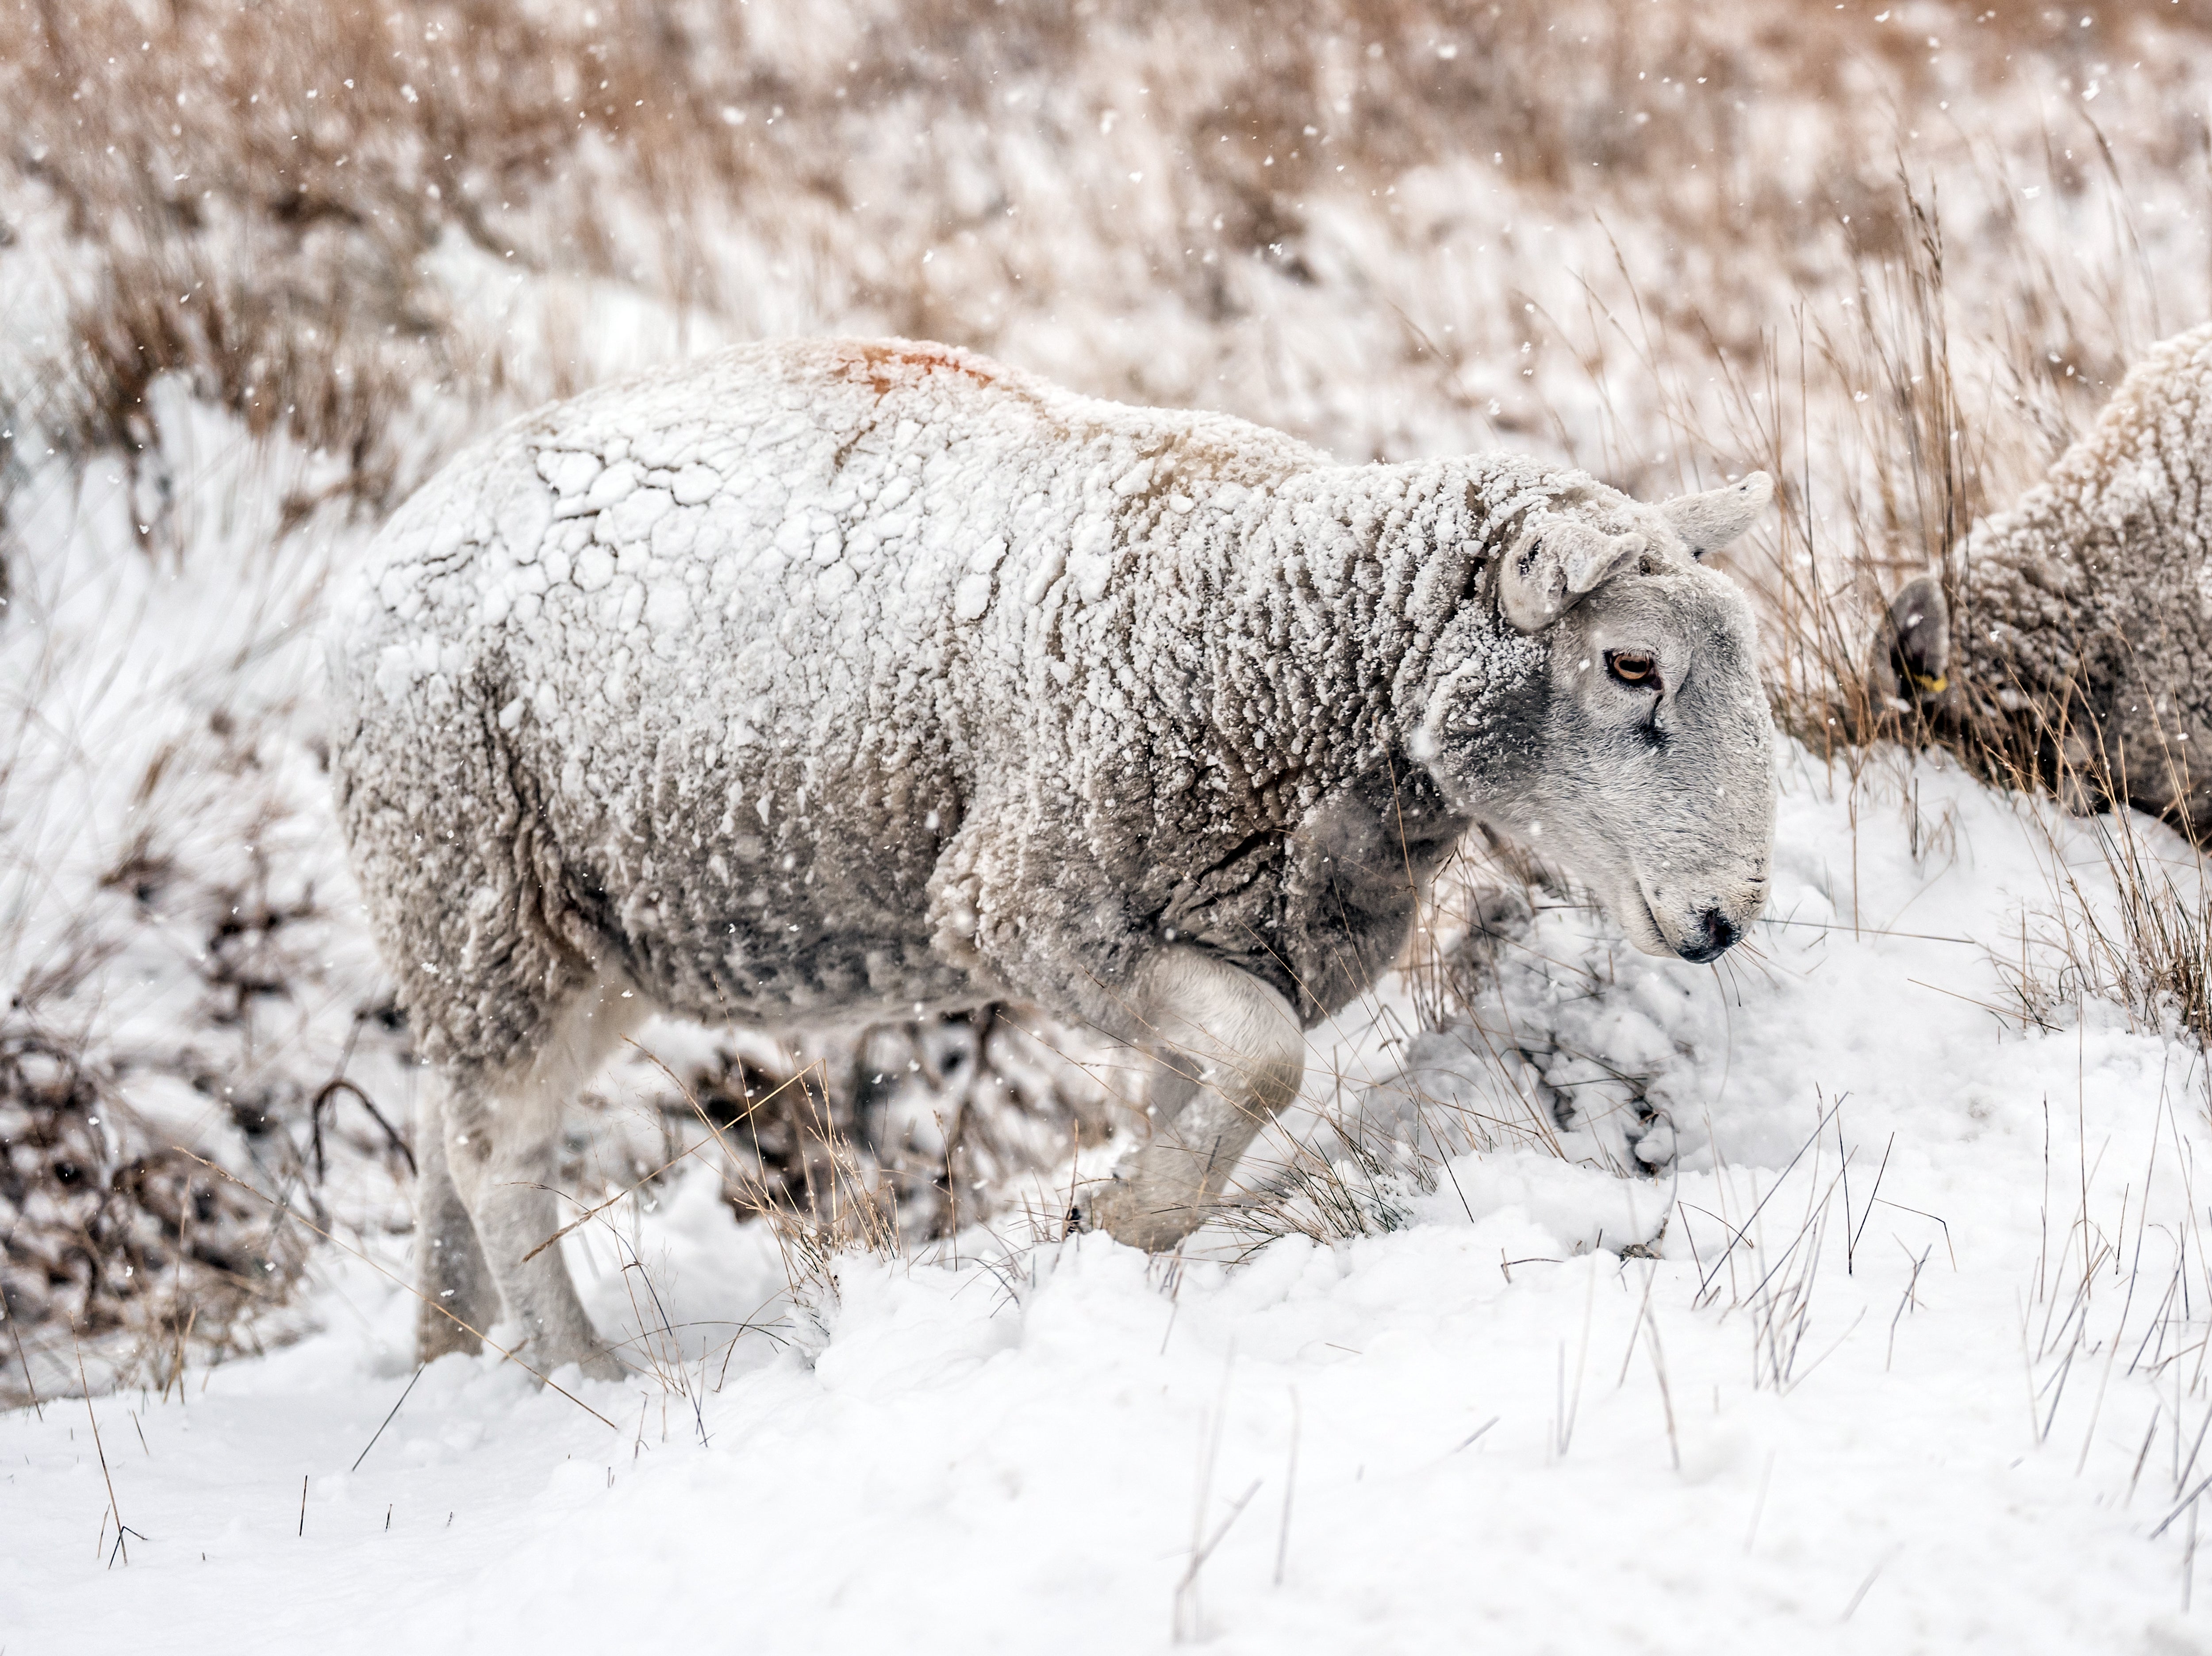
[1079,948,1305,1251]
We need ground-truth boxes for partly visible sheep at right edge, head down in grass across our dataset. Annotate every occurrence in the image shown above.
[1867,323,2212,838]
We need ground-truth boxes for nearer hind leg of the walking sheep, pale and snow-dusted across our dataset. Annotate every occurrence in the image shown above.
[431,988,646,1380]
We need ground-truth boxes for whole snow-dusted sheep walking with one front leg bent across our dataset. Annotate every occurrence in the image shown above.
[332,341,1774,1375]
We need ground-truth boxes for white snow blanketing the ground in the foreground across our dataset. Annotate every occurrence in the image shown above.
[13,752,2212,1656]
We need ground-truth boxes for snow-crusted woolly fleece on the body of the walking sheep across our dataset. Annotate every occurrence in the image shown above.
[334,343,1644,1070]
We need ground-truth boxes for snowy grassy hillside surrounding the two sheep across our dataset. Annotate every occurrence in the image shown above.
[13,0,2212,1652]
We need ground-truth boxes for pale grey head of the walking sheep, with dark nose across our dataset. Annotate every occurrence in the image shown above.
[1413,473,1774,962]
